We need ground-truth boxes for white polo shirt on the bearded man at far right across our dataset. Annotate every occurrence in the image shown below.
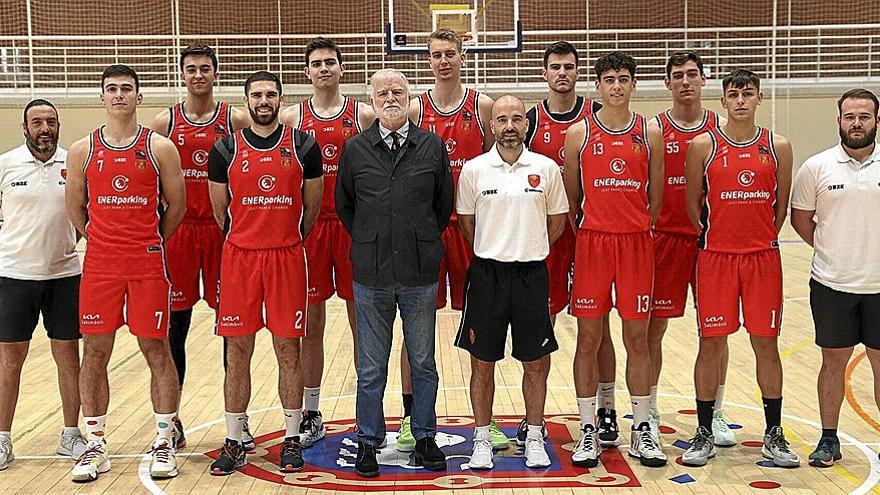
[791,144,880,294]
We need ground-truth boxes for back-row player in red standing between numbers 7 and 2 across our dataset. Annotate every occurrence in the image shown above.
[150,45,250,448]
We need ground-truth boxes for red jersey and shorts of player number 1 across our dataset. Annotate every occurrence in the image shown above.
[697,127,782,337]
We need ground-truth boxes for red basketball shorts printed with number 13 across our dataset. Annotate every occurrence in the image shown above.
[569,230,654,320]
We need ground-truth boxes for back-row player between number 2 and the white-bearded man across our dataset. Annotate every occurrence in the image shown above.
[281,37,376,448]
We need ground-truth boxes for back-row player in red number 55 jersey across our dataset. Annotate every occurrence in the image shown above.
[648,51,736,446]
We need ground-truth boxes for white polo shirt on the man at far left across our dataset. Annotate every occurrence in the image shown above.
[0,144,82,280]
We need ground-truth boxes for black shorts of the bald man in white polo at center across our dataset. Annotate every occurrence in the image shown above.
[455,256,559,361]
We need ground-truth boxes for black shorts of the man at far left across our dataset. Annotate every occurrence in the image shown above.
[0,275,82,342]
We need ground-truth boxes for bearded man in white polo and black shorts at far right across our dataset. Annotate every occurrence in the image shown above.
[791,89,880,467]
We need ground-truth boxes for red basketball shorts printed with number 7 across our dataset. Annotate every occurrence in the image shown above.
[79,273,171,338]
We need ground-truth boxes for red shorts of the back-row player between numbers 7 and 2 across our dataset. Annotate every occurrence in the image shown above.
[165,223,223,311]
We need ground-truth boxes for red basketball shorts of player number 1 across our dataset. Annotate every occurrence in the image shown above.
[697,249,782,337]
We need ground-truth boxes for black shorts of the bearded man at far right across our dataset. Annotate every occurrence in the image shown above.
[810,279,880,349]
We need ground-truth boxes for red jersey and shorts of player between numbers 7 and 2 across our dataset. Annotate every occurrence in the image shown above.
[165,102,232,311]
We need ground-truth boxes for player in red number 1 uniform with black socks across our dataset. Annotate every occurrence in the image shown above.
[682,70,799,467]
